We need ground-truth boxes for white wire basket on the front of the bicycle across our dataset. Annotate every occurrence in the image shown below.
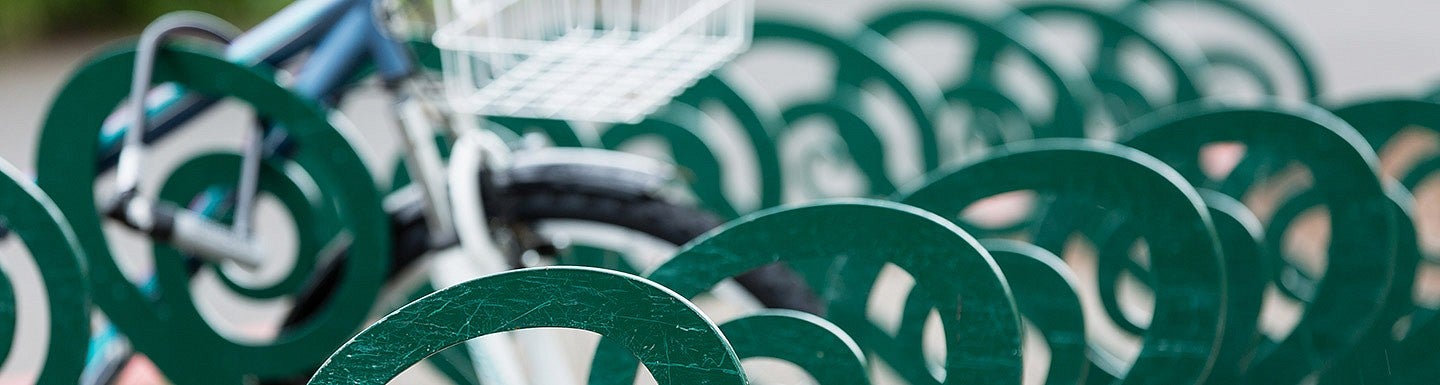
[433,0,755,123]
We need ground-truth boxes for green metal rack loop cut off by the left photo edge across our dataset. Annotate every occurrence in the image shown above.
[0,160,91,384]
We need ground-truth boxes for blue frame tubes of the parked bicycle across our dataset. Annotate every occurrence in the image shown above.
[98,0,413,172]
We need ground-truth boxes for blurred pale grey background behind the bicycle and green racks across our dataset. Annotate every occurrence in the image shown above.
[0,0,1440,383]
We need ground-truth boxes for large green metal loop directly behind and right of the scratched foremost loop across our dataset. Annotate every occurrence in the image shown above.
[590,200,1022,384]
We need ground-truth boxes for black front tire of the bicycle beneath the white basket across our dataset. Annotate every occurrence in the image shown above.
[284,153,824,331]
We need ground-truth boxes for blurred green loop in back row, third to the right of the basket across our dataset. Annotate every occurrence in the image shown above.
[1020,3,1204,124]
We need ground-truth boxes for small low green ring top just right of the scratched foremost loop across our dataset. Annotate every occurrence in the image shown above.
[720,310,870,385]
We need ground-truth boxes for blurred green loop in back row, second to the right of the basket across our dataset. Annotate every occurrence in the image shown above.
[867,6,1094,141]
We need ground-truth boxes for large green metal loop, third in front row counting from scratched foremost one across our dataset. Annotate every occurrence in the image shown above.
[896,138,1225,384]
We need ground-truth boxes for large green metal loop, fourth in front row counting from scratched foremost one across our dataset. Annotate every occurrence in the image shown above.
[1125,102,1397,384]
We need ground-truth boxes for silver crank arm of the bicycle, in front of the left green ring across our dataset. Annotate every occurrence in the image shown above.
[107,195,265,270]
